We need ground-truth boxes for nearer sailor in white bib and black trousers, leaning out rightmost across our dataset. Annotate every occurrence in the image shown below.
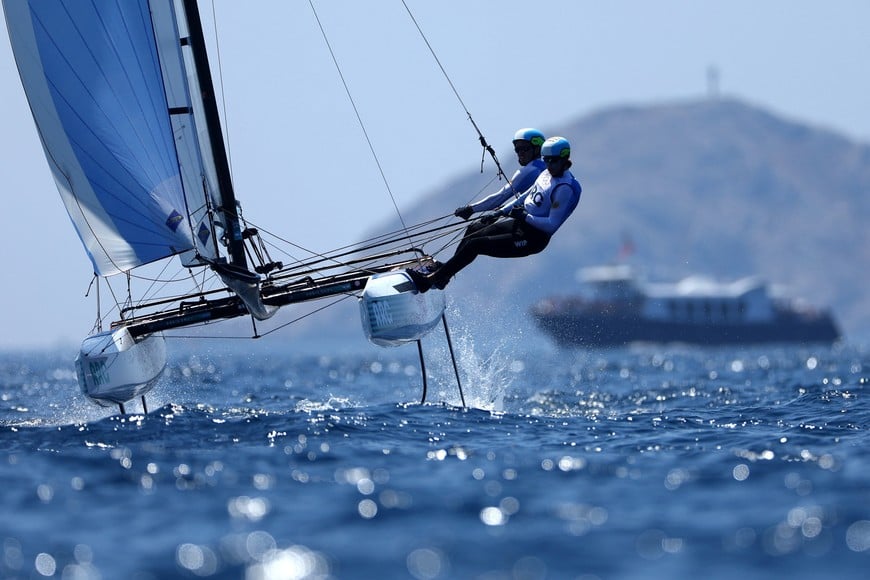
[408,137,582,292]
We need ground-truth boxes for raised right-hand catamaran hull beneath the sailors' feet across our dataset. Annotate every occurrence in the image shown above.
[359,271,446,346]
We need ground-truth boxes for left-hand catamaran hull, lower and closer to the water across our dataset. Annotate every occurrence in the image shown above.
[76,327,166,407]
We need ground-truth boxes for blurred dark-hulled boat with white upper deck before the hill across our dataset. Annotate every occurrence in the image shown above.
[531,265,840,346]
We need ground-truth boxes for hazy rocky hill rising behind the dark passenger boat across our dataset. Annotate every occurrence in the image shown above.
[282,99,870,348]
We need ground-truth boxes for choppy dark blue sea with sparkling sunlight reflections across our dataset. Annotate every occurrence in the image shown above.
[0,338,870,580]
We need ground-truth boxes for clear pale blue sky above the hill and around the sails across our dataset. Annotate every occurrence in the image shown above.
[0,0,870,349]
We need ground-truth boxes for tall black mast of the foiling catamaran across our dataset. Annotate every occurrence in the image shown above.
[182,0,248,269]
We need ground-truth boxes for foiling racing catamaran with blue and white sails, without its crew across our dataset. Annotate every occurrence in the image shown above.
[3,0,461,413]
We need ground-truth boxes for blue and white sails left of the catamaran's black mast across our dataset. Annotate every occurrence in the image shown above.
[3,0,216,276]
